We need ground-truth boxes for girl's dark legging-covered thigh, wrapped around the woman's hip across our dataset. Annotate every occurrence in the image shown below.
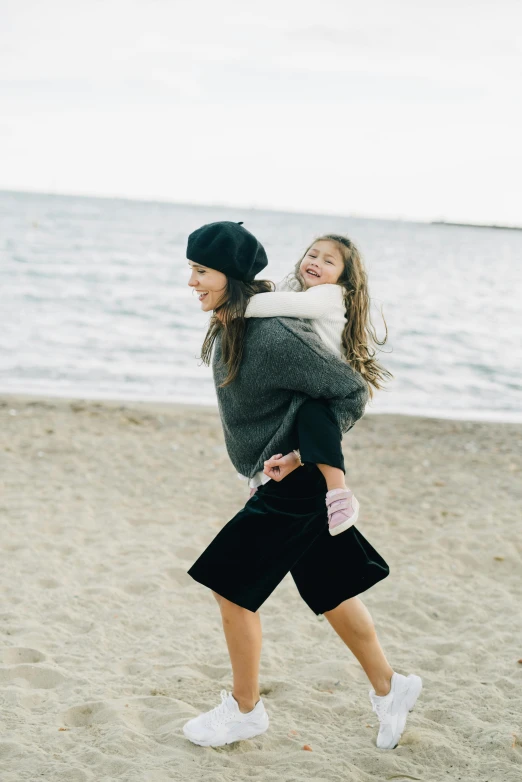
[296,399,346,472]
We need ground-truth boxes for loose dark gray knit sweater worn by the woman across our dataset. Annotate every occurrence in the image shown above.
[212,318,368,477]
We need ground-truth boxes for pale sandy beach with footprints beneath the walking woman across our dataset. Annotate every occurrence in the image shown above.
[0,395,522,782]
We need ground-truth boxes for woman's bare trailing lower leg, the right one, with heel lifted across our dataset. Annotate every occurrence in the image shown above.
[324,597,393,695]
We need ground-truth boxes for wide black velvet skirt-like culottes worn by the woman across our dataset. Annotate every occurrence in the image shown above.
[188,464,389,614]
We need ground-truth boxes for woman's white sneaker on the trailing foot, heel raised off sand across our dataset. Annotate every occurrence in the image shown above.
[370,673,422,749]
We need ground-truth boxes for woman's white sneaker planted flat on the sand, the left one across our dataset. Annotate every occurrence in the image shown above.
[183,690,268,747]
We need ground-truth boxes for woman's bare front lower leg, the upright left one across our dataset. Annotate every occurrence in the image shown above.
[212,592,262,714]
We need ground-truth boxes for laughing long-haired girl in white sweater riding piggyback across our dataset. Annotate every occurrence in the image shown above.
[245,234,391,535]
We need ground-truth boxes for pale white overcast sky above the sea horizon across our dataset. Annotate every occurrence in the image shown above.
[0,0,522,225]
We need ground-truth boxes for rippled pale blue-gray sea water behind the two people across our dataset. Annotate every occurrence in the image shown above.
[0,192,522,421]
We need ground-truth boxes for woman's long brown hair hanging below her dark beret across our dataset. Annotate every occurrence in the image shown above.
[201,277,275,388]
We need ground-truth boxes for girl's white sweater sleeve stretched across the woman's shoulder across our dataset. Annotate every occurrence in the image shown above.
[245,284,341,320]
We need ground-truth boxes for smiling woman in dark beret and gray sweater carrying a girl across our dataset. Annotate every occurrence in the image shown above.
[183,222,422,749]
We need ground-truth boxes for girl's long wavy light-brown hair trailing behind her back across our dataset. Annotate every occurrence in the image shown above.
[293,234,393,398]
